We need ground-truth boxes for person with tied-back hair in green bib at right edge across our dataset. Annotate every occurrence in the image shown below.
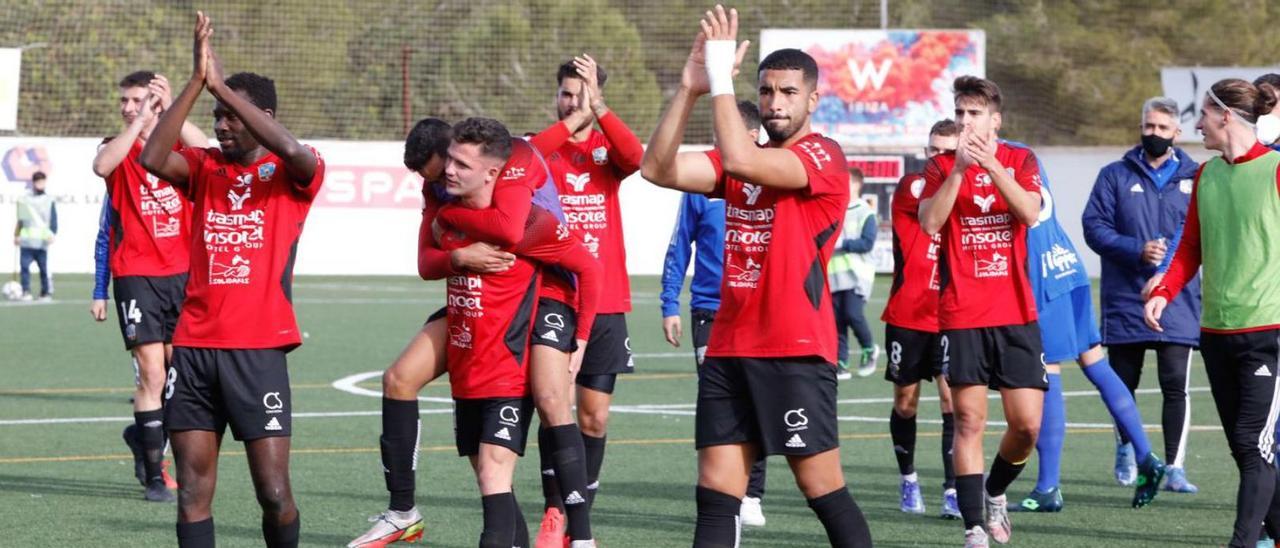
[1144,78,1280,547]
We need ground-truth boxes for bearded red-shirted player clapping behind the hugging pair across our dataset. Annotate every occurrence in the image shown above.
[531,54,644,530]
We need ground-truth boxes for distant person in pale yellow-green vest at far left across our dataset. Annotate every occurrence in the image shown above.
[13,172,58,301]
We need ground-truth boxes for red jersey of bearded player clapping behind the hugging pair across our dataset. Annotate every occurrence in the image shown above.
[532,111,644,314]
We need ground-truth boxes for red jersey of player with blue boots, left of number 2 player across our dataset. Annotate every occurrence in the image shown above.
[881,173,942,333]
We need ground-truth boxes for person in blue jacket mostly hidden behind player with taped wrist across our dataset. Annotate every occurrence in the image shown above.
[662,101,764,528]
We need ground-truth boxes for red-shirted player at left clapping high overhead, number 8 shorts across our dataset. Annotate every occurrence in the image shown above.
[141,13,325,547]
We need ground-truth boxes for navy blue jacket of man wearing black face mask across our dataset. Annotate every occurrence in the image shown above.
[1080,146,1201,346]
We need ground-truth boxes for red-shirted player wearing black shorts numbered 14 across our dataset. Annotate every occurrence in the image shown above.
[93,70,209,502]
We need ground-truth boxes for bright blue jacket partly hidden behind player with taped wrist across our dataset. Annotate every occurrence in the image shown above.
[662,193,724,318]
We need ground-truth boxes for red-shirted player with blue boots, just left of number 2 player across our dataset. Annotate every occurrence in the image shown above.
[881,120,960,520]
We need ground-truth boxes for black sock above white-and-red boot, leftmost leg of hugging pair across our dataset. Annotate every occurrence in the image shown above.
[380,398,421,512]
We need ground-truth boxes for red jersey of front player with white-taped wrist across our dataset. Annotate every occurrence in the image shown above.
[707,133,849,364]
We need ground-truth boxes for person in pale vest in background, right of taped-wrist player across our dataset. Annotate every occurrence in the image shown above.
[827,168,881,380]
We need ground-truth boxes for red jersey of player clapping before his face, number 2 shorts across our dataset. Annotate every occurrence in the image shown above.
[920,143,1039,330]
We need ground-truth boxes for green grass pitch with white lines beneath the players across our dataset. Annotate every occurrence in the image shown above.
[0,277,1236,547]
